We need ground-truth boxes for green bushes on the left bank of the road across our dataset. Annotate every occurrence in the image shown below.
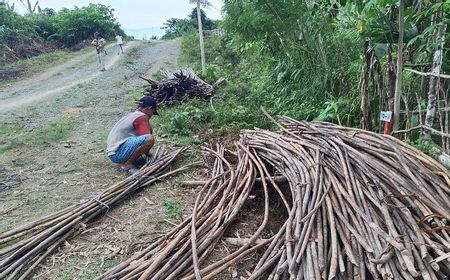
[0,1,124,64]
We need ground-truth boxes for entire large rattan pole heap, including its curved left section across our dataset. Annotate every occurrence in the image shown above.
[100,118,450,280]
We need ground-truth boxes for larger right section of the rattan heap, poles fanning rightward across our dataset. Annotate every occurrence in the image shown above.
[246,118,450,279]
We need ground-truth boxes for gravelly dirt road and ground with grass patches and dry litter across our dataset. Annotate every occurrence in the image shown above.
[0,41,199,279]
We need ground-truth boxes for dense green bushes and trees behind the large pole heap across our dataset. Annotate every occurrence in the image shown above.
[163,0,450,151]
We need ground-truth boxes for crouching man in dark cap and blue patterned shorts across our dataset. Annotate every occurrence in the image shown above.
[107,96,158,174]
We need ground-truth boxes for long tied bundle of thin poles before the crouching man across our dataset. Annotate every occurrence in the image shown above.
[0,148,198,279]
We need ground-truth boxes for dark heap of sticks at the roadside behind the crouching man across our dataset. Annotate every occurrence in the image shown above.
[139,68,214,105]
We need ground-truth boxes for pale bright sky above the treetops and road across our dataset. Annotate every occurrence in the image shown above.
[6,0,222,29]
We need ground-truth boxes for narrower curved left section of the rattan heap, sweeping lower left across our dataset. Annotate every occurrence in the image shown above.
[97,144,264,279]
